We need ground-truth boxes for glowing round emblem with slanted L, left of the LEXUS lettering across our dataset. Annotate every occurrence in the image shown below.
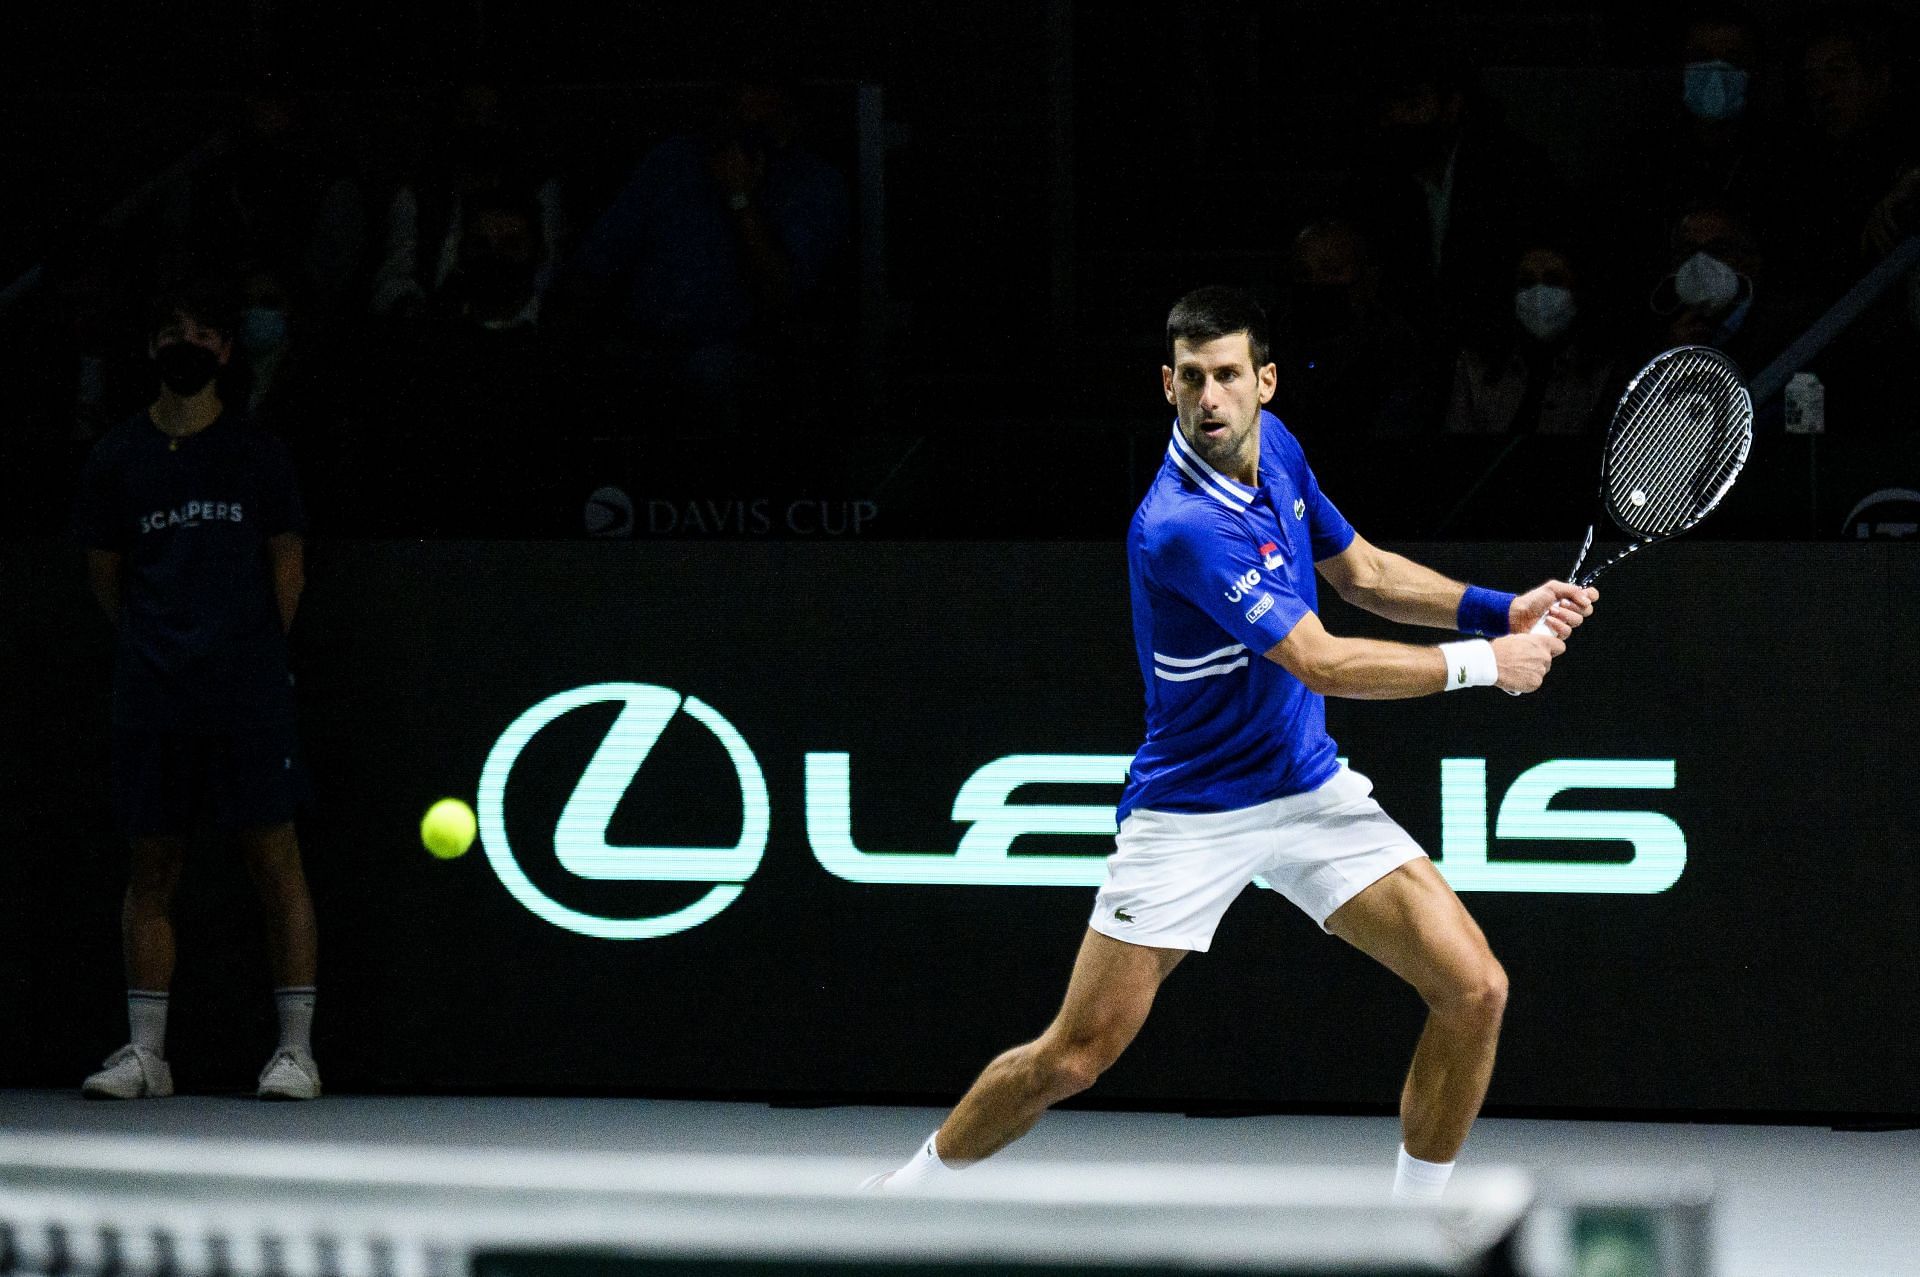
[478,684,768,939]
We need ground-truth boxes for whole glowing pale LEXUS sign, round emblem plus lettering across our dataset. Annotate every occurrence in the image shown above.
[478,683,1688,939]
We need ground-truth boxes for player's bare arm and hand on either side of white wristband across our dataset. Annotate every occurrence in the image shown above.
[1267,613,1567,701]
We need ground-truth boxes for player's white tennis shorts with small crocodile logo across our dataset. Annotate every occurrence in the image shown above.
[1089,766,1427,952]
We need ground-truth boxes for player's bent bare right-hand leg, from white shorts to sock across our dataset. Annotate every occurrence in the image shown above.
[1327,858,1507,1164]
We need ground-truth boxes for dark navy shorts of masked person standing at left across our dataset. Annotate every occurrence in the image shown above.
[113,724,307,837]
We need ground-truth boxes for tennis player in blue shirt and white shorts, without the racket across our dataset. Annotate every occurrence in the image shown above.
[862,288,1599,1200]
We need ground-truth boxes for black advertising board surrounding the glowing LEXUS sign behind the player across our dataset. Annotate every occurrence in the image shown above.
[0,537,1920,1120]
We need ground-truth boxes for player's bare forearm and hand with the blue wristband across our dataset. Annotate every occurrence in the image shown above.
[1313,532,1599,639]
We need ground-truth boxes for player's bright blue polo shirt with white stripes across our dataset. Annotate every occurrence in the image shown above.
[1117,411,1354,820]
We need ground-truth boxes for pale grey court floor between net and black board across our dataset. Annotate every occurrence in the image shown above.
[0,1091,1920,1277]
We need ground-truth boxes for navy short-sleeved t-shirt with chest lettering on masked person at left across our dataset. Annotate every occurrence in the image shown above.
[73,411,305,732]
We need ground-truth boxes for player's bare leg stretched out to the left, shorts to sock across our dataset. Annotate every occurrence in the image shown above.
[935,929,1187,1166]
